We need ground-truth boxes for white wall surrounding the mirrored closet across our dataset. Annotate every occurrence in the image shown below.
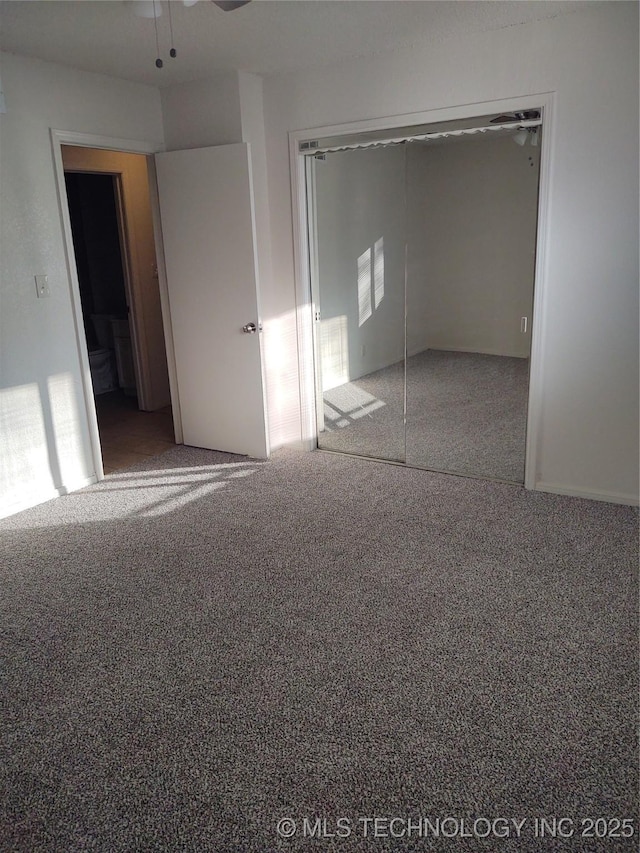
[263,2,638,501]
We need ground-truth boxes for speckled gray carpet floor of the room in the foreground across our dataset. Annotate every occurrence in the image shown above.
[0,447,638,853]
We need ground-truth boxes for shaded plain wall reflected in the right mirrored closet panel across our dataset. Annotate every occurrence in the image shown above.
[407,135,540,358]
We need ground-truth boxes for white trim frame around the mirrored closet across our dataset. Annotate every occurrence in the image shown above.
[289,92,555,489]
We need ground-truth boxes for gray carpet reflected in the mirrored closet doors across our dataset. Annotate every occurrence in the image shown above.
[318,350,529,483]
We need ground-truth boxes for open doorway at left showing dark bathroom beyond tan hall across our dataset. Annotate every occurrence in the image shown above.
[62,146,175,474]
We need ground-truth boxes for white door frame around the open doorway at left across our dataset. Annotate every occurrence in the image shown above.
[50,128,182,480]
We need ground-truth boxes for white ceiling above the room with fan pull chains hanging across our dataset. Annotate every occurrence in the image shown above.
[0,0,600,87]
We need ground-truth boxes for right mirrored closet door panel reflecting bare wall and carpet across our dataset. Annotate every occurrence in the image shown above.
[406,131,540,482]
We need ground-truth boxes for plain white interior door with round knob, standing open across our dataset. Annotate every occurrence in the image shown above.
[156,143,269,458]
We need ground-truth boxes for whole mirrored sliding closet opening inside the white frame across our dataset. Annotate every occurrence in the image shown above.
[301,109,542,483]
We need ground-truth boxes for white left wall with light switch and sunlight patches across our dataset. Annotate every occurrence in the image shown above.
[0,54,163,515]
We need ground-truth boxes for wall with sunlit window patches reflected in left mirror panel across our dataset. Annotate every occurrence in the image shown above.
[314,146,406,391]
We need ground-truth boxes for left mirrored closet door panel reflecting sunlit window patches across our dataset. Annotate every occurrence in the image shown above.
[307,146,405,461]
